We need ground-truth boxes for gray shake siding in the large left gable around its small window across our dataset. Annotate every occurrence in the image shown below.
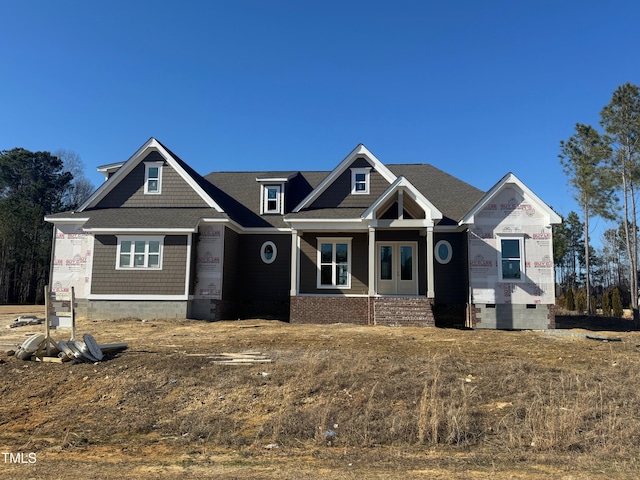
[95,152,208,208]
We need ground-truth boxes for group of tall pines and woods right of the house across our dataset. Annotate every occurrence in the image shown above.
[554,83,640,319]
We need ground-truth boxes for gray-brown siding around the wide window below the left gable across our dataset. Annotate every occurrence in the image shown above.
[91,235,187,295]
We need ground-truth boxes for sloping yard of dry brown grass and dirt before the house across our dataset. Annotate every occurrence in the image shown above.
[0,307,640,480]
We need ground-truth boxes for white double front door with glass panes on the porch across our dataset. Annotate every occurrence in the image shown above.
[376,242,418,295]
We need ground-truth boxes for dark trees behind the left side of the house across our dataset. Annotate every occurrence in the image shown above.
[0,148,93,304]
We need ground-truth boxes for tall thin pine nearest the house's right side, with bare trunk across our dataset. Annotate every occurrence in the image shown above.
[559,123,614,311]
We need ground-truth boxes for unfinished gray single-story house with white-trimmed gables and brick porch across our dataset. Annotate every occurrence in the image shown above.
[46,138,561,329]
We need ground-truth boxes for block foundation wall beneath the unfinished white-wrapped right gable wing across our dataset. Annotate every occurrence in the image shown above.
[471,304,556,330]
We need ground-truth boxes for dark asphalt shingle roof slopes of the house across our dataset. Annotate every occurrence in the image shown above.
[48,155,485,229]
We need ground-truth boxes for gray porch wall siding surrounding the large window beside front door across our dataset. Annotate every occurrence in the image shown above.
[300,232,369,295]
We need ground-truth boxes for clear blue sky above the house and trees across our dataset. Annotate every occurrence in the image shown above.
[0,0,640,238]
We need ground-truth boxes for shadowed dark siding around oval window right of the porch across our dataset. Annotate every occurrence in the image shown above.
[433,232,469,304]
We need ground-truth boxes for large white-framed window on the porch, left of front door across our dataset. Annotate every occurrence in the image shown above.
[317,238,351,288]
